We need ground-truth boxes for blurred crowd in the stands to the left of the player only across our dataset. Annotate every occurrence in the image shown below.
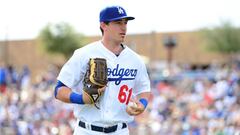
[0,63,75,135]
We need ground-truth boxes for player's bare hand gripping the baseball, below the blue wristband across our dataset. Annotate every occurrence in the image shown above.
[126,100,144,116]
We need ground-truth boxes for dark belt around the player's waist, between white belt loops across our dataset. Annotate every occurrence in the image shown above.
[78,121,127,133]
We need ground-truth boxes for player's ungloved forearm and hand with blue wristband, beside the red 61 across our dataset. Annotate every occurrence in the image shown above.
[126,92,151,115]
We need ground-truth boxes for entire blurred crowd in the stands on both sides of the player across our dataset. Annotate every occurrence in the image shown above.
[0,63,240,135]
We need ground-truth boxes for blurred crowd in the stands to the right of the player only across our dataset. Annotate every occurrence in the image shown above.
[133,63,240,135]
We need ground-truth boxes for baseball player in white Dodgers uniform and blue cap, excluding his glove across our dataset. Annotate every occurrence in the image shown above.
[55,6,150,135]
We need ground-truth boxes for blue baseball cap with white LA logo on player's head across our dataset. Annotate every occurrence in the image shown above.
[99,6,135,22]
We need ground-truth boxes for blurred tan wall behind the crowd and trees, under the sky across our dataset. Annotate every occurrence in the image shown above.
[0,32,226,82]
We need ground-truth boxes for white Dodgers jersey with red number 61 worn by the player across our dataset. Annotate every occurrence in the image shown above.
[58,41,150,126]
